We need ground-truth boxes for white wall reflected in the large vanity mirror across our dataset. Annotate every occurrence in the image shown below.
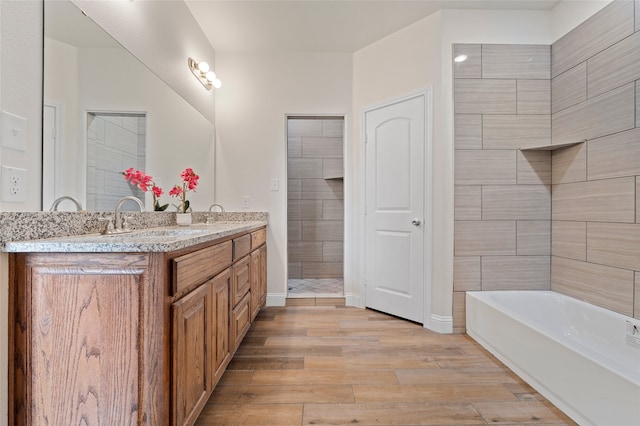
[45,39,215,210]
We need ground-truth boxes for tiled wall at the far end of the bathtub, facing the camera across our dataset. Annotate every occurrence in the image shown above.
[453,44,551,332]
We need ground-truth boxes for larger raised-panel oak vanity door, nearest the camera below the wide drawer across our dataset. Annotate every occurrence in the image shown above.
[172,281,214,425]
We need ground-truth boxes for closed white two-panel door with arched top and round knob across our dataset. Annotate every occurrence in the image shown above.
[364,93,427,323]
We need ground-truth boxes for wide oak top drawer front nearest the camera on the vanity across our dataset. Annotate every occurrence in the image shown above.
[172,241,232,294]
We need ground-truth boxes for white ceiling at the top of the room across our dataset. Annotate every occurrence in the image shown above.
[185,0,560,53]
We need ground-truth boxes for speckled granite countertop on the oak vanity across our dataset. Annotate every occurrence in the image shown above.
[3,220,267,253]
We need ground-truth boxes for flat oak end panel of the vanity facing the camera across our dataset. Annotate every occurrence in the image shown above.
[10,253,169,425]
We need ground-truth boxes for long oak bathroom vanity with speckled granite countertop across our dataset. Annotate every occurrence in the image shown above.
[5,221,267,425]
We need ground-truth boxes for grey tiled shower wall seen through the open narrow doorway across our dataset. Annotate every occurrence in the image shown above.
[287,117,344,279]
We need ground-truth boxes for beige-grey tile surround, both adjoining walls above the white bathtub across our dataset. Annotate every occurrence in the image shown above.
[454,0,640,332]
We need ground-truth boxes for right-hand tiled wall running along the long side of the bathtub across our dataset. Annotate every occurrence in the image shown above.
[551,0,640,318]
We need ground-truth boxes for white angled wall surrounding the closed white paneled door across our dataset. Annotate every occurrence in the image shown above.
[352,12,442,320]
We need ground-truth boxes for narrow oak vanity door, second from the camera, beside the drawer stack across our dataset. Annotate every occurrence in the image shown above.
[211,268,231,388]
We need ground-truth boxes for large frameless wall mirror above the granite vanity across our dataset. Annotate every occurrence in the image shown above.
[43,1,214,210]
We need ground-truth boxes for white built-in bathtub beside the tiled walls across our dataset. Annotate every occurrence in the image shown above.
[466,291,640,426]
